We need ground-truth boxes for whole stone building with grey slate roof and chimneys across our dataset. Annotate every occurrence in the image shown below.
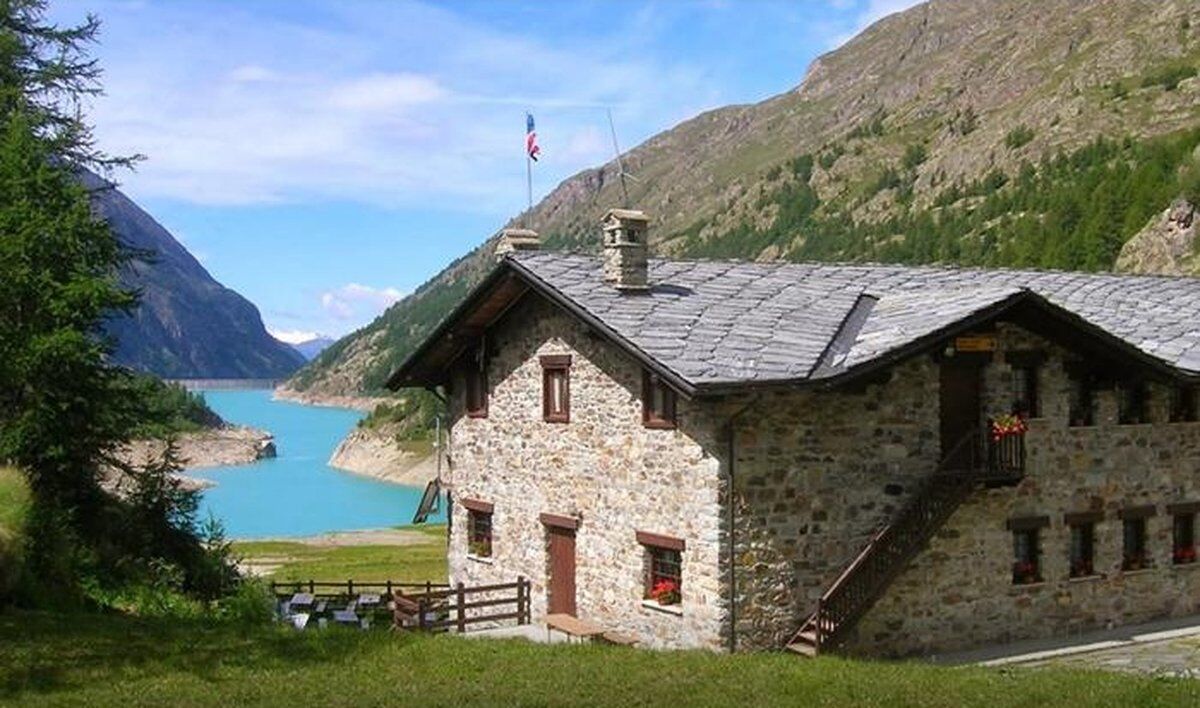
[390,210,1200,656]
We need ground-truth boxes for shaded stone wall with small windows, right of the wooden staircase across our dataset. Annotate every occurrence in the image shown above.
[847,326,1200,655]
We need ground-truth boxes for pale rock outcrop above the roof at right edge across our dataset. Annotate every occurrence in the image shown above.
[1116,199,1200,275]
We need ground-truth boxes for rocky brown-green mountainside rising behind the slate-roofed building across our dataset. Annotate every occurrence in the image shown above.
[287,0,1200,396]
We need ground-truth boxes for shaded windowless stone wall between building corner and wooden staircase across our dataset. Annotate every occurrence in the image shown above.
[734,356,940,649]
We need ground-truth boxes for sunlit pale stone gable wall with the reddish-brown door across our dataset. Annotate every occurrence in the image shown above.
[448,296,725,648]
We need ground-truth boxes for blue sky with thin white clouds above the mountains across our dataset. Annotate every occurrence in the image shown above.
[52,0,916,340]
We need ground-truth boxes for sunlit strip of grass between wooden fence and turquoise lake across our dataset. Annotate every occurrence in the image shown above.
[234,524,446,582]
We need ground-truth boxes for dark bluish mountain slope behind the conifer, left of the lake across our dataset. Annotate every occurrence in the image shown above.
[80,172,305,378]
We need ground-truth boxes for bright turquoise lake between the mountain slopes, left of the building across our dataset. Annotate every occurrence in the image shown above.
[188,390,436,539]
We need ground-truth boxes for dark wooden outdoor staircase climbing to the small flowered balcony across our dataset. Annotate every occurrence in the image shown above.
[786,426,1025,656]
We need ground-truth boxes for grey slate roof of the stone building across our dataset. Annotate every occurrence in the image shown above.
[508,252,1200,388]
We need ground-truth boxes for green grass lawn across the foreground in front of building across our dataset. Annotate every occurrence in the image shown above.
[0,612,1200,708]
